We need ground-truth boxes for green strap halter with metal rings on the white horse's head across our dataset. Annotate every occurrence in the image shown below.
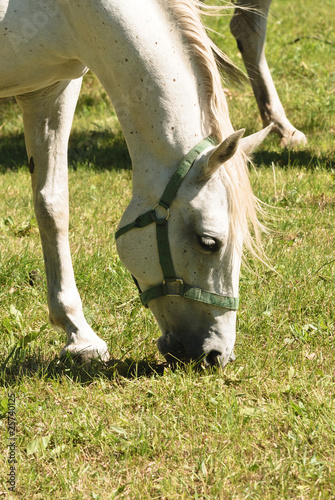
[115,137,238,311]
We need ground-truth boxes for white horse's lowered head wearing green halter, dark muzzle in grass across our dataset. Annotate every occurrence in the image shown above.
[116,127,271,366]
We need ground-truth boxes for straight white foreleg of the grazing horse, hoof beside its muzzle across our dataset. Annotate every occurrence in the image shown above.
[16,80,109,361]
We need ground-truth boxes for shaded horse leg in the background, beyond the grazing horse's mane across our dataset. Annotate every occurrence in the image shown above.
[230,0,307,146]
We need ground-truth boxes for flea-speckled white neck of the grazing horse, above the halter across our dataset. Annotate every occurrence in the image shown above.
[71,0,217,201]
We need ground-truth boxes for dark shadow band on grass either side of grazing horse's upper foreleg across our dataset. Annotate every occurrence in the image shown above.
[0,130,131,174]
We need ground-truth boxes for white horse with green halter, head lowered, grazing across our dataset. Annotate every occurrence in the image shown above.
[0,0,268,366]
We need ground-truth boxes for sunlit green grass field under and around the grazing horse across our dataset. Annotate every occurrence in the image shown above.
[0,0,335,500]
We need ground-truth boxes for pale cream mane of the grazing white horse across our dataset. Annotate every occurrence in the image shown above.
[163,0,265,261]
